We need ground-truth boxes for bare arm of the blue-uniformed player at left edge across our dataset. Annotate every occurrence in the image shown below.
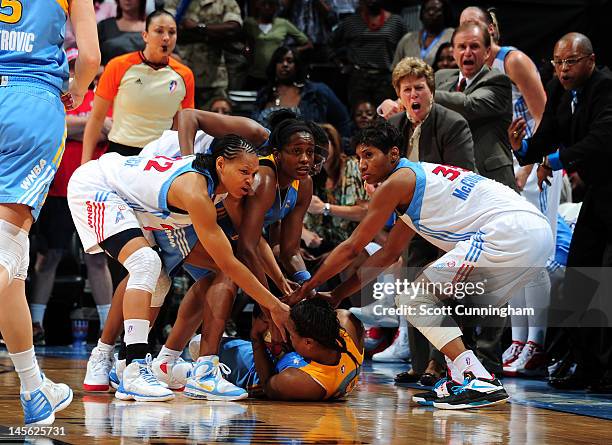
[64,0,100,110]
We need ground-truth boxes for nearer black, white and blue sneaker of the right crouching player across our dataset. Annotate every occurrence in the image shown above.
[433,372,510,409]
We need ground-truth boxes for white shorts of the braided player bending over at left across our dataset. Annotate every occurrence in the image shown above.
[68,161,149,253]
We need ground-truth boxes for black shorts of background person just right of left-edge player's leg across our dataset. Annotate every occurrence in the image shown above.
[36,196,76,250]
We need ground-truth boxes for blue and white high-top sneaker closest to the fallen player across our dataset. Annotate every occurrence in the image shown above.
[184,355,249,401]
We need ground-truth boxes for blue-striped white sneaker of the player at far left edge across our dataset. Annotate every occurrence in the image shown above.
[20,374,72,425]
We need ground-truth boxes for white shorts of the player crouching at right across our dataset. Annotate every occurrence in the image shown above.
[423,211,554,306]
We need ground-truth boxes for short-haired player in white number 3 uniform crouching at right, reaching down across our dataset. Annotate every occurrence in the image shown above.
[291,123,553,409]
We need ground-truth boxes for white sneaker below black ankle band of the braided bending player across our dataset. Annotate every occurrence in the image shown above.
[115,354,174,402]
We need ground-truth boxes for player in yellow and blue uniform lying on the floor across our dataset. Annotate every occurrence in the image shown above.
[189,293,364,401]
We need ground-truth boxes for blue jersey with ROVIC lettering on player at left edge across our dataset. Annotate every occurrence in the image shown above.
[0,0,68,91]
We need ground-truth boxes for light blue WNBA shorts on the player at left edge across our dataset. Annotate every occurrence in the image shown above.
[0,80,66,220]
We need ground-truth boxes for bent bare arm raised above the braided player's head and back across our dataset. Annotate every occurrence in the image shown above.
[178,108,268,156]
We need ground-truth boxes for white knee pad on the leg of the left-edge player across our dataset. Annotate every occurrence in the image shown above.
[0,221,30,283]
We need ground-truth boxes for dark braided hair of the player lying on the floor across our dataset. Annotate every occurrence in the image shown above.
[289,298,359,367]
